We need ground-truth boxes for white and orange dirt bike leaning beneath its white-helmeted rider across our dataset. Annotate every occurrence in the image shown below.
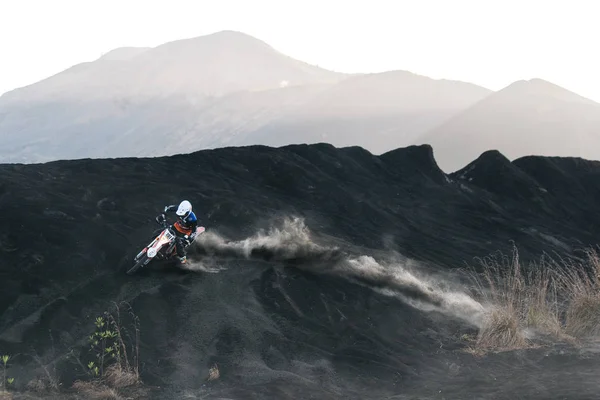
[127,214,205,275]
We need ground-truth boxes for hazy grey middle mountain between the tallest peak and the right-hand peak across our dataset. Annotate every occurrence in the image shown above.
[242,71,491,153]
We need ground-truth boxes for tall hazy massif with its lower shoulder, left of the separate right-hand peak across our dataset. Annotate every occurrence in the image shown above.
[0,31,490,163]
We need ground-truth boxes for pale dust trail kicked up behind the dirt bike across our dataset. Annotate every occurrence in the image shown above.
[189,218,484,326]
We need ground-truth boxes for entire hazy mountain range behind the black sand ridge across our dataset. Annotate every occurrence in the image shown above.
[0,31,600,167]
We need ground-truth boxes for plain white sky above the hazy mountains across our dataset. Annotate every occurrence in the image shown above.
[0,0,600,101]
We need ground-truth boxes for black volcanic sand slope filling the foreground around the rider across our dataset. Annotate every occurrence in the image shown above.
[0,144,600,399]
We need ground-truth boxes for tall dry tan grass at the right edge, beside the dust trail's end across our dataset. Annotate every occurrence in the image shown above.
[471,244,600,350]
